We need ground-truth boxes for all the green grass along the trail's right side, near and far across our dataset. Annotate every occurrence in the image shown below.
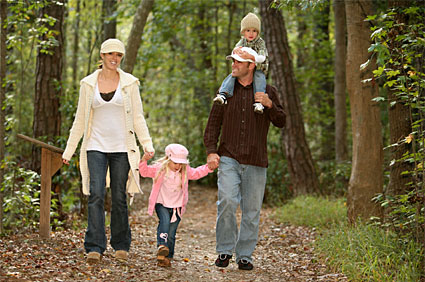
[274,196,424,282]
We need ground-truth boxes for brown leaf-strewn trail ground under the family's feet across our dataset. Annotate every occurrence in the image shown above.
[0,185,348,282]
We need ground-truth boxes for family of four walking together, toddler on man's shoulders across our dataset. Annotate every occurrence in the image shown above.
[62,13,285,270]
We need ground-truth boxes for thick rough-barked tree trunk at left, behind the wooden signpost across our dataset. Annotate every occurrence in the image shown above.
[32,0,65,171]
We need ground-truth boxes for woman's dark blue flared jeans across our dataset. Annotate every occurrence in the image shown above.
[84,151,131,254]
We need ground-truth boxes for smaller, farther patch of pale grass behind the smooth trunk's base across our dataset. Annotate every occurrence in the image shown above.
[275,196,347,229]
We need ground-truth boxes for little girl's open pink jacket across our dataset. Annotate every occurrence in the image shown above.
[139,161,213,215]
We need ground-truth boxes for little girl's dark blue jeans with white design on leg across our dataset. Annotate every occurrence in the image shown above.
[155,204,181,258]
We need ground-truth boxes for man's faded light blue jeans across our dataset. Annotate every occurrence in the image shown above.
[216,156,267,262]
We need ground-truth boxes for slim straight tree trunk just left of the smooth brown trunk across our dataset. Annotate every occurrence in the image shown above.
[333,0,348,187]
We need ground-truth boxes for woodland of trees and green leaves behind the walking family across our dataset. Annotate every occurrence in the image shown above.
[0,0,425,280]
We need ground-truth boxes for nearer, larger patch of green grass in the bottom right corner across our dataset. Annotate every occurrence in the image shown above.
[315,222,424,282]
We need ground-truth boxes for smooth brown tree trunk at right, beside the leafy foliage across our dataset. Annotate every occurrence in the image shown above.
[345,0,383,223]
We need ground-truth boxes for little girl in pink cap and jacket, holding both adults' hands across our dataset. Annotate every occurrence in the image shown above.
[139,144,213,266]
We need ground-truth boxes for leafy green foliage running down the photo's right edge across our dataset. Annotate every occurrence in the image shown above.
[365,5,425,241]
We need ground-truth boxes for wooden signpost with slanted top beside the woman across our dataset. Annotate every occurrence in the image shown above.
[16,134,63,239]
